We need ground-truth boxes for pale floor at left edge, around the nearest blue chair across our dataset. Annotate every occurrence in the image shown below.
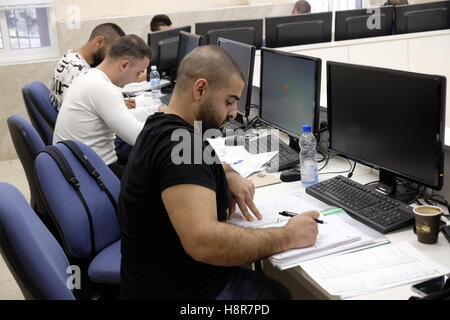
[0,159,30,300]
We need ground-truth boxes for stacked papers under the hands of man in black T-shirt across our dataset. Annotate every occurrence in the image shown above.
[229,191,388,270]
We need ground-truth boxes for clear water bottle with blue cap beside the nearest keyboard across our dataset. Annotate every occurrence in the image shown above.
[298,125,319,187]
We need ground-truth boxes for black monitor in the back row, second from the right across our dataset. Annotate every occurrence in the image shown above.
[334,6,394,41]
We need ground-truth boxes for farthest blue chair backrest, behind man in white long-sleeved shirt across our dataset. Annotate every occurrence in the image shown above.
[22,81,58,145]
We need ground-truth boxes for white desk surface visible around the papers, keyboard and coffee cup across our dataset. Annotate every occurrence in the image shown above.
[255,157,450,300]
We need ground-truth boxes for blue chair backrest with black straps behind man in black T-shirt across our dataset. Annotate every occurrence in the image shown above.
[35,142,120,258]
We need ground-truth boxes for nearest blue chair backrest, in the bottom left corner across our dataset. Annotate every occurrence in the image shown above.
[0,183,75,300]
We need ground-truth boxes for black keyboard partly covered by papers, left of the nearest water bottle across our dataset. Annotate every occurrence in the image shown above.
[244,134,300,172]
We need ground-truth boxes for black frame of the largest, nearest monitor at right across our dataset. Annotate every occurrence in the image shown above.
[327,61,446,190]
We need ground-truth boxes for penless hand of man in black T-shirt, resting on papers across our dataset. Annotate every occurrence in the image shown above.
[225,169,262,221]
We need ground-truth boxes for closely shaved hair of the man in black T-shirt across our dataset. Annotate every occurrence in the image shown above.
[175,45,244,91]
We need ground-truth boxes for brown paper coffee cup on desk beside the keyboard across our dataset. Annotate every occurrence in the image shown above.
[413,205,442,244]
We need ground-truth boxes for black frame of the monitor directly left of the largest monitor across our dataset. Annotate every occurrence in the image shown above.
[258,47,322,139]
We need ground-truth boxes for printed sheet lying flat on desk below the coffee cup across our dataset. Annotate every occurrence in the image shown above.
[300,242,450,298]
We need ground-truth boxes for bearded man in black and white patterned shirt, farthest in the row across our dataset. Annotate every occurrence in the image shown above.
[51,23,125,111]
